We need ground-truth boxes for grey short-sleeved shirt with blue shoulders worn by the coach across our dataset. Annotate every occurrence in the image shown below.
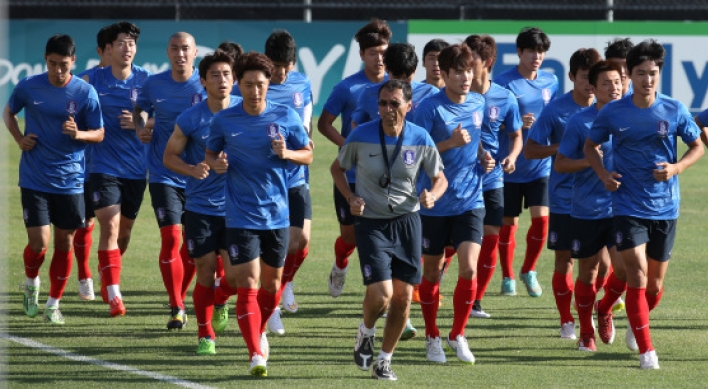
[337,119,443,219]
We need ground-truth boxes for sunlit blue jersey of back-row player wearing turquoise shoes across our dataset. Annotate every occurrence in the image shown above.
[494,67,558,183]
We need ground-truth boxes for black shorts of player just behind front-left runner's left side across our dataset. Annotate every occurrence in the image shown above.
[184,210,227,258]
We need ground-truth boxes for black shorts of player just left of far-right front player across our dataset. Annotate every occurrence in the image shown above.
[570,218,615,259]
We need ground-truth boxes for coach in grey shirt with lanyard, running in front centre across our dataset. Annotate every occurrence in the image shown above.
[331,80,447,381]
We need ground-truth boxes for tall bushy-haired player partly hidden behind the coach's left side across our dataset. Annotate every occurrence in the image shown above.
[317,19,392,297]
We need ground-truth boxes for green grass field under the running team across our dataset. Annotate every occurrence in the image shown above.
[0,116,708,388]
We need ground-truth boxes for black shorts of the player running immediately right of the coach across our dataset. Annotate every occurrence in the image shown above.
[420,208,484,255]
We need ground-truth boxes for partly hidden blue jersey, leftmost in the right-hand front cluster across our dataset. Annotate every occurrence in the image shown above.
[528,91,585,215]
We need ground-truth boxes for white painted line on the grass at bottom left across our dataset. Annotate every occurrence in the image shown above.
[0,333,213,389]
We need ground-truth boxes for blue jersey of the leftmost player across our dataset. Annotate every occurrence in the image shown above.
[7,73,103,194]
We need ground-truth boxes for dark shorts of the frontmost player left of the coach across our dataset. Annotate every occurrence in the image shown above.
[226,228,290,268]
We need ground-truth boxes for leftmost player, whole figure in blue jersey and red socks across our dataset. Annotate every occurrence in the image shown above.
[3,35,103,325]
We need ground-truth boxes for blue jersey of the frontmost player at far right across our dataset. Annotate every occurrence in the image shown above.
[588,94,701,220]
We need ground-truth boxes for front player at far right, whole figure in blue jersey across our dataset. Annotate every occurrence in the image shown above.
[584,40,703,369]
